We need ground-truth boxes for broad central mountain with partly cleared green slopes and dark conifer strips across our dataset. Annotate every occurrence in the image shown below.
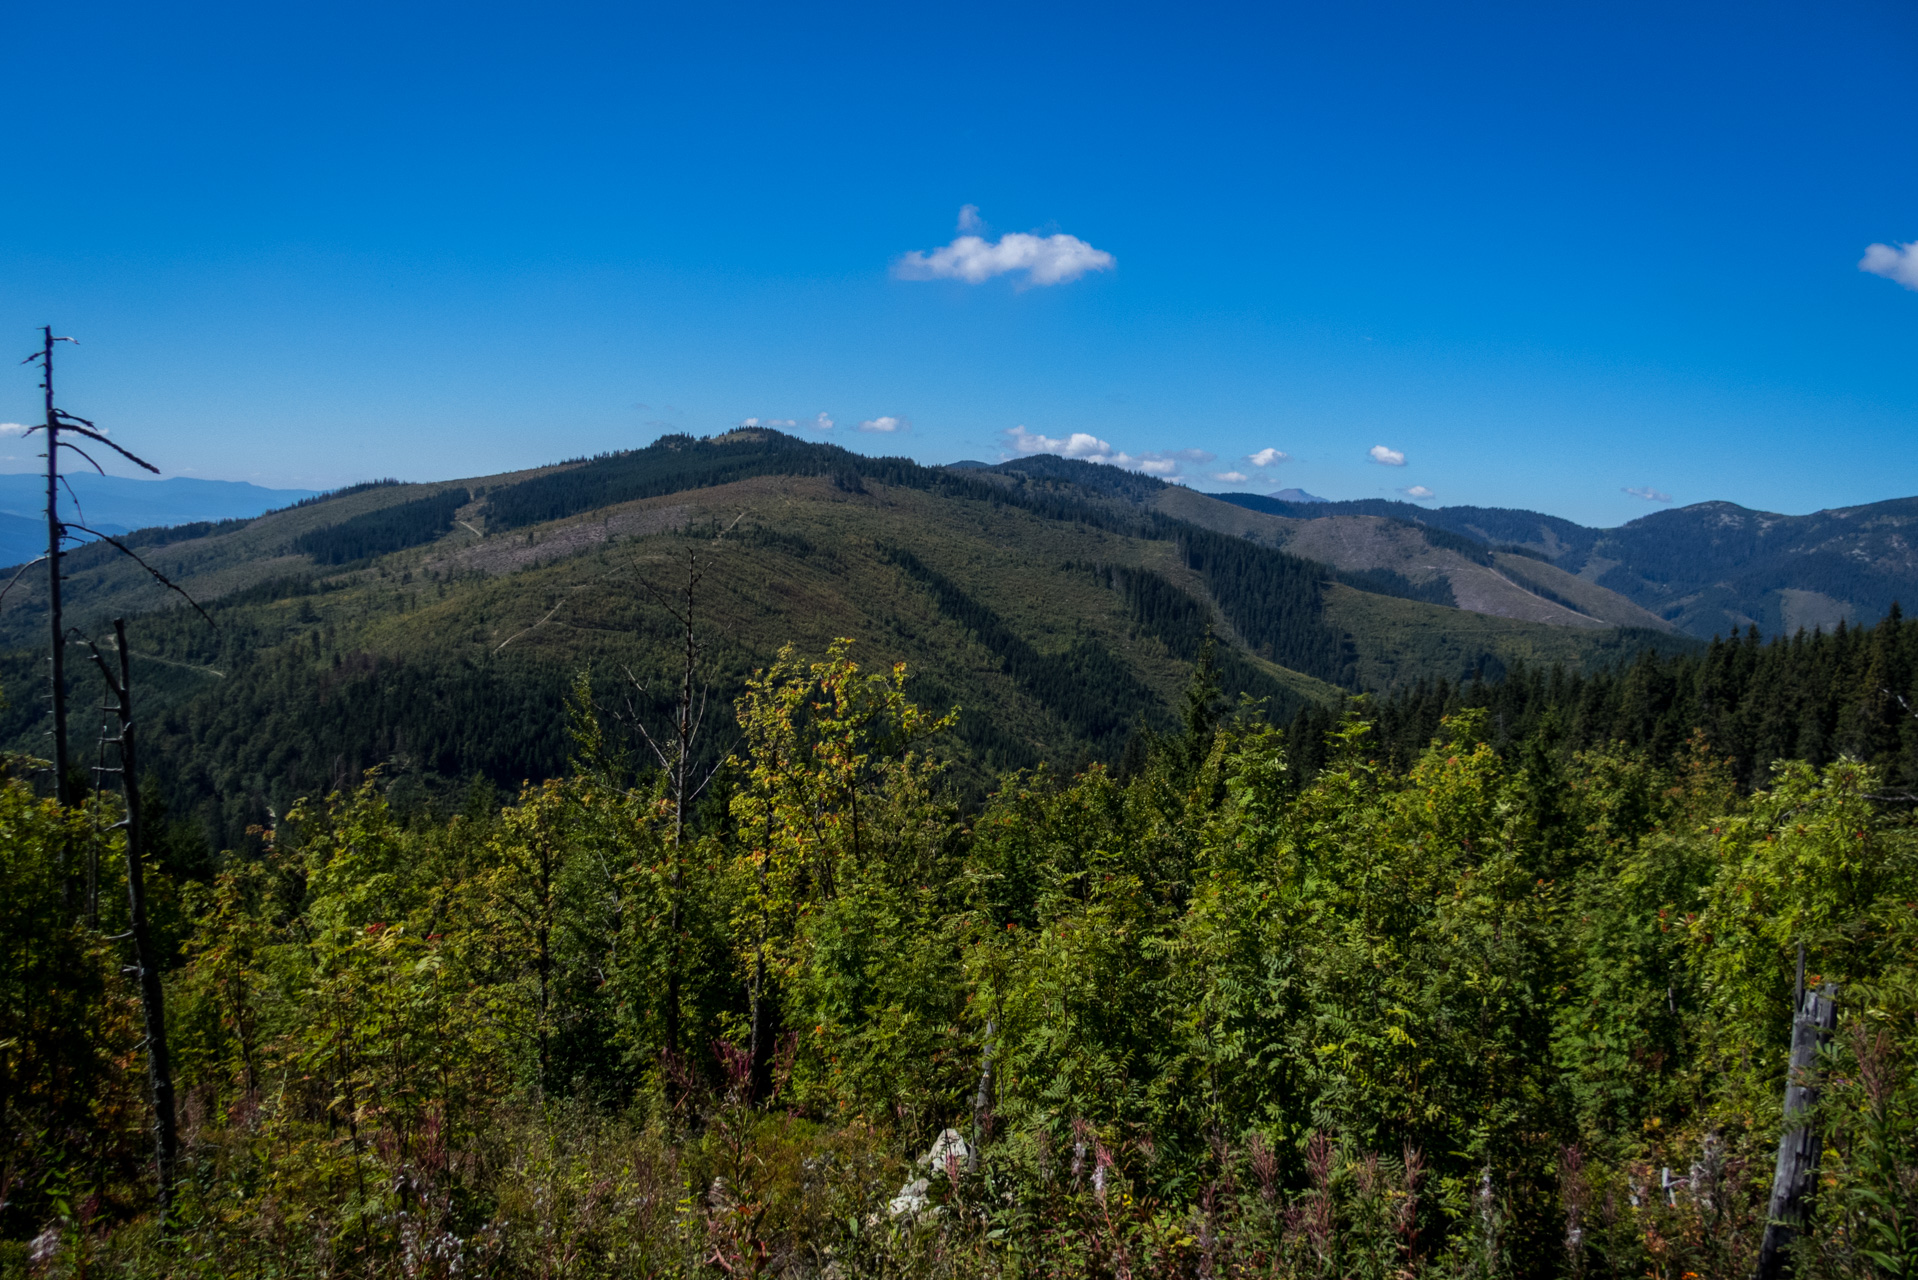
[0,430,1686,844]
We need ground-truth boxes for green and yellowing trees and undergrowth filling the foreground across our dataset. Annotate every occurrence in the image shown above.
[0,606,1918,1280]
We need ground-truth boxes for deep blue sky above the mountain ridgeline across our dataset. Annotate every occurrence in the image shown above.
[0,0,1918,524]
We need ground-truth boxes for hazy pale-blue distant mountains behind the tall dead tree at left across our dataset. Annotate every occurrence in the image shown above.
[0,472,315,564]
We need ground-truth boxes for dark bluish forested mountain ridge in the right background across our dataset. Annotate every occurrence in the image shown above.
[1220,493,1918,639]
